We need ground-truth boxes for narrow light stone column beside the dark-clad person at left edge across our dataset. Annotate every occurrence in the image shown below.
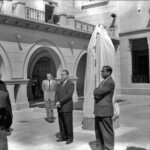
[6,84,17,110]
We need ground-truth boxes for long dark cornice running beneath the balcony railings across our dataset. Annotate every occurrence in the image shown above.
[0,13,92,40]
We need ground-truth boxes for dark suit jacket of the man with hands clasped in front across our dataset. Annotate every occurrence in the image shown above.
[55,79,74,112]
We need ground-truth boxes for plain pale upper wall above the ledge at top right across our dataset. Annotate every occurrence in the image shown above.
[119,1,150,33]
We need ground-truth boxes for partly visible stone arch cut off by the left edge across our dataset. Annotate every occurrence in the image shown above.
[0,44,12,80]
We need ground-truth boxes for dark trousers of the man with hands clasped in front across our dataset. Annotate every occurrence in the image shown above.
[58,112,73,141]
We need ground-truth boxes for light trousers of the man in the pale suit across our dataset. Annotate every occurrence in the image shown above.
[45,100,55,121]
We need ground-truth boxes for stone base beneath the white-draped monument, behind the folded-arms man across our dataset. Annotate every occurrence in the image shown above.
[82,117,120,130]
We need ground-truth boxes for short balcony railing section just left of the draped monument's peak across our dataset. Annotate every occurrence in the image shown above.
[75,20,95,32]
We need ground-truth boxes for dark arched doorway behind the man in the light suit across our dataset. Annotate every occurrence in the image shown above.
[28,56,56,101]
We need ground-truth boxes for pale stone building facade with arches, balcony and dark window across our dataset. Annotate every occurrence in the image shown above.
[0,0,150,109]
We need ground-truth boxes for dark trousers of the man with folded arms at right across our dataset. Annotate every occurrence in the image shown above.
[95,116,114,150]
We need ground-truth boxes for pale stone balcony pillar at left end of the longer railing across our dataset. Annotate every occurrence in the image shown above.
[13,2,26,18]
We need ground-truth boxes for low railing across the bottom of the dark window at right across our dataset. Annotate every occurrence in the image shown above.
[132,75,149,83]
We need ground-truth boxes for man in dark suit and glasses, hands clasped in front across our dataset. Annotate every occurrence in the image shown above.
[55,70,74,144]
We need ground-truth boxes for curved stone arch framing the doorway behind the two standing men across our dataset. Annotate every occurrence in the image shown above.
[23,39,66,78]
